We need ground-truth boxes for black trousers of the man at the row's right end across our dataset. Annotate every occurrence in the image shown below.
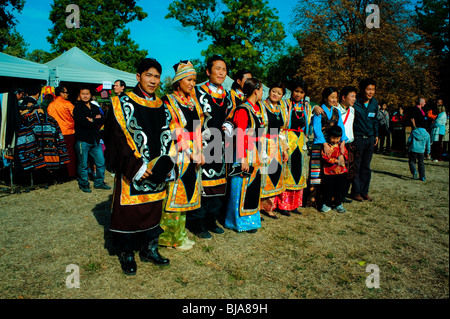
[352,136,375,195]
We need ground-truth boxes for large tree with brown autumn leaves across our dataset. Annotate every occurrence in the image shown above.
[294,0,436,105]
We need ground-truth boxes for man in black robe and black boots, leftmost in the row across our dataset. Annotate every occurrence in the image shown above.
[104,58,176,275]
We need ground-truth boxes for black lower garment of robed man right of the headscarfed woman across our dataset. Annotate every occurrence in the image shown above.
[186,196,223,233]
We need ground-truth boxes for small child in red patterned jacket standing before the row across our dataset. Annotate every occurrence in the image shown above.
[321,125,348,213]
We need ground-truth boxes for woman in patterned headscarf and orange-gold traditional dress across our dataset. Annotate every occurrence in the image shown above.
[159,61,203,250]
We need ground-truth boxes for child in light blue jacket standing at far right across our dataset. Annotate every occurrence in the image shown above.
[406,124,431,182]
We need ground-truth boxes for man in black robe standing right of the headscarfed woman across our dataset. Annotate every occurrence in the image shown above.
[186,55,233,239]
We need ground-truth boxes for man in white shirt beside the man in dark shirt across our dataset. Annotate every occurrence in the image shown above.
[337,86,356,203]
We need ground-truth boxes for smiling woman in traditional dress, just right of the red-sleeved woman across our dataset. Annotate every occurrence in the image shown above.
[261,82,289,219]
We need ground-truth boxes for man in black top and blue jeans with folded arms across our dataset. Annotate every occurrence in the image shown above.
[73,87,111,193]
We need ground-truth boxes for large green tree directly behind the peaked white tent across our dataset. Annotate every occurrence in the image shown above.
[47,0,148,72]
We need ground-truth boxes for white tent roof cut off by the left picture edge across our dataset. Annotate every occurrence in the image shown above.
[0,52,49,81]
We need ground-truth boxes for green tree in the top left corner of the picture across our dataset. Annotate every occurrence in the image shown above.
[0,0,28,58]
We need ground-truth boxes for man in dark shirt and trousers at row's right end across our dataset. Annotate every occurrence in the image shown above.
[351,79,378,202]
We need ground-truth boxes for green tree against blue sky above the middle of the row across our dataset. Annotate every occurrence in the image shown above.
[166,0,286,79]
